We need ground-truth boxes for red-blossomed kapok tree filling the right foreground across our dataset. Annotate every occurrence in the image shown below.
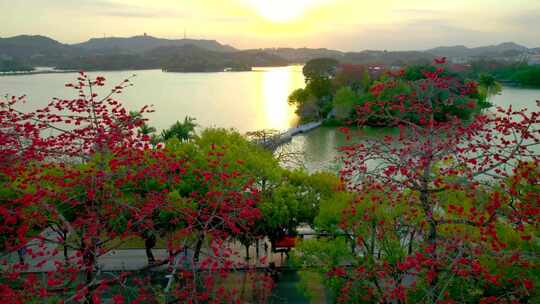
[336,61,540,303]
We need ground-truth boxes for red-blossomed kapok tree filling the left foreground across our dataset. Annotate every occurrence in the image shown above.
[0,73,270,303]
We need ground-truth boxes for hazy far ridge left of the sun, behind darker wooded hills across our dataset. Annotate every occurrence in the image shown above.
[72,35,236,54]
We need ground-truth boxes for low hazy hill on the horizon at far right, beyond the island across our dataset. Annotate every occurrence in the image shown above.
[426,42,529,57]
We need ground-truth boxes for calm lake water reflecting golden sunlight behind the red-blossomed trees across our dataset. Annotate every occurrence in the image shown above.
[0,66,540,171]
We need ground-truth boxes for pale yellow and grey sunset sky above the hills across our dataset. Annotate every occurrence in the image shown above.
[0,0,540,51]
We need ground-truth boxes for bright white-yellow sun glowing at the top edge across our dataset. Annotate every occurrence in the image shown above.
[249,0,318,22]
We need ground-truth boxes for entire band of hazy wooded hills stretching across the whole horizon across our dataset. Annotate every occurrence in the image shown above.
[0,34,536,72]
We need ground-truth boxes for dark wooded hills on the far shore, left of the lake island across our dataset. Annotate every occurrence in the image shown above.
[0,36,289,72]
